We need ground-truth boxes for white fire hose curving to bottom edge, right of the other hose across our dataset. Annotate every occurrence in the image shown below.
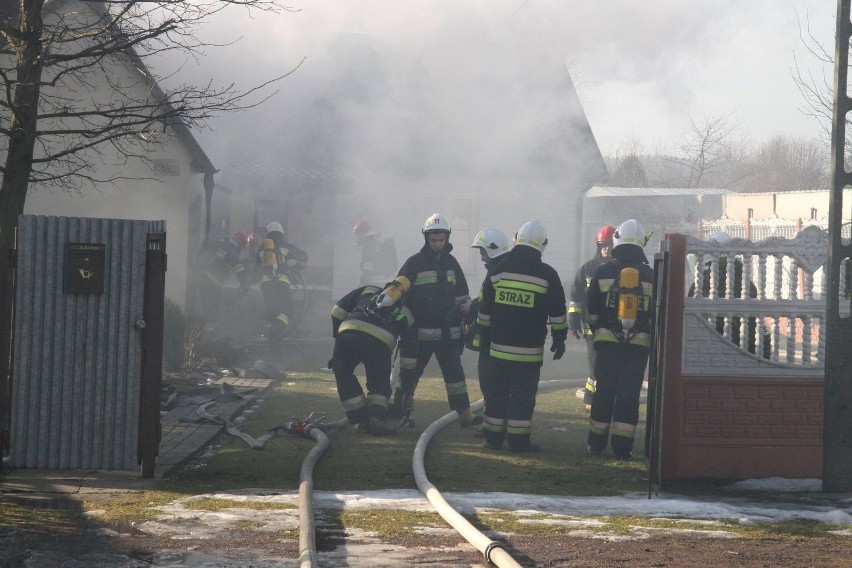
[411,379,585,568]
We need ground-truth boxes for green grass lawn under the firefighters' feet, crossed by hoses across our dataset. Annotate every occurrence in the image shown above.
[163,372,648,496]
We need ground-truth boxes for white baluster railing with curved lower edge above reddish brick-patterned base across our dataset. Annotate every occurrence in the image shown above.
[684,224,850,376]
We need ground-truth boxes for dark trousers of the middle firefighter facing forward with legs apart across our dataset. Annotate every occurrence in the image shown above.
[394,339,470,412]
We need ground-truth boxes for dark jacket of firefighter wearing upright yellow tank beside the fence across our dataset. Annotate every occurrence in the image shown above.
[586,245,654,348]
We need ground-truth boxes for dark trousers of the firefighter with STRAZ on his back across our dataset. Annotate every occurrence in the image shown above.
[482,357,541,449]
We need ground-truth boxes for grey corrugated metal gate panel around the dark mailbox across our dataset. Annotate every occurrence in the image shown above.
[9,215,164,469]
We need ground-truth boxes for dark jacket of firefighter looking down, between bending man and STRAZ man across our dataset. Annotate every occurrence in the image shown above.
[399,243,470,341]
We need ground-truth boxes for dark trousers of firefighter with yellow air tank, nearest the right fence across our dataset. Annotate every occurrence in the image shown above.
[588,342,649,458]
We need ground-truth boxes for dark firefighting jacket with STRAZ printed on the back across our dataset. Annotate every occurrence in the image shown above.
[477,245,568,364]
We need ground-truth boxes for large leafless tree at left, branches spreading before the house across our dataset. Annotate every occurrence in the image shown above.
[0,0,290,458]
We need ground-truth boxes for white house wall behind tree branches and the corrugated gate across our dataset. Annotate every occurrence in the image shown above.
[8,0,213,305]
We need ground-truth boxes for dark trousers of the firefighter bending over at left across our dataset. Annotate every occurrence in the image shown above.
[332,330,391,424]
